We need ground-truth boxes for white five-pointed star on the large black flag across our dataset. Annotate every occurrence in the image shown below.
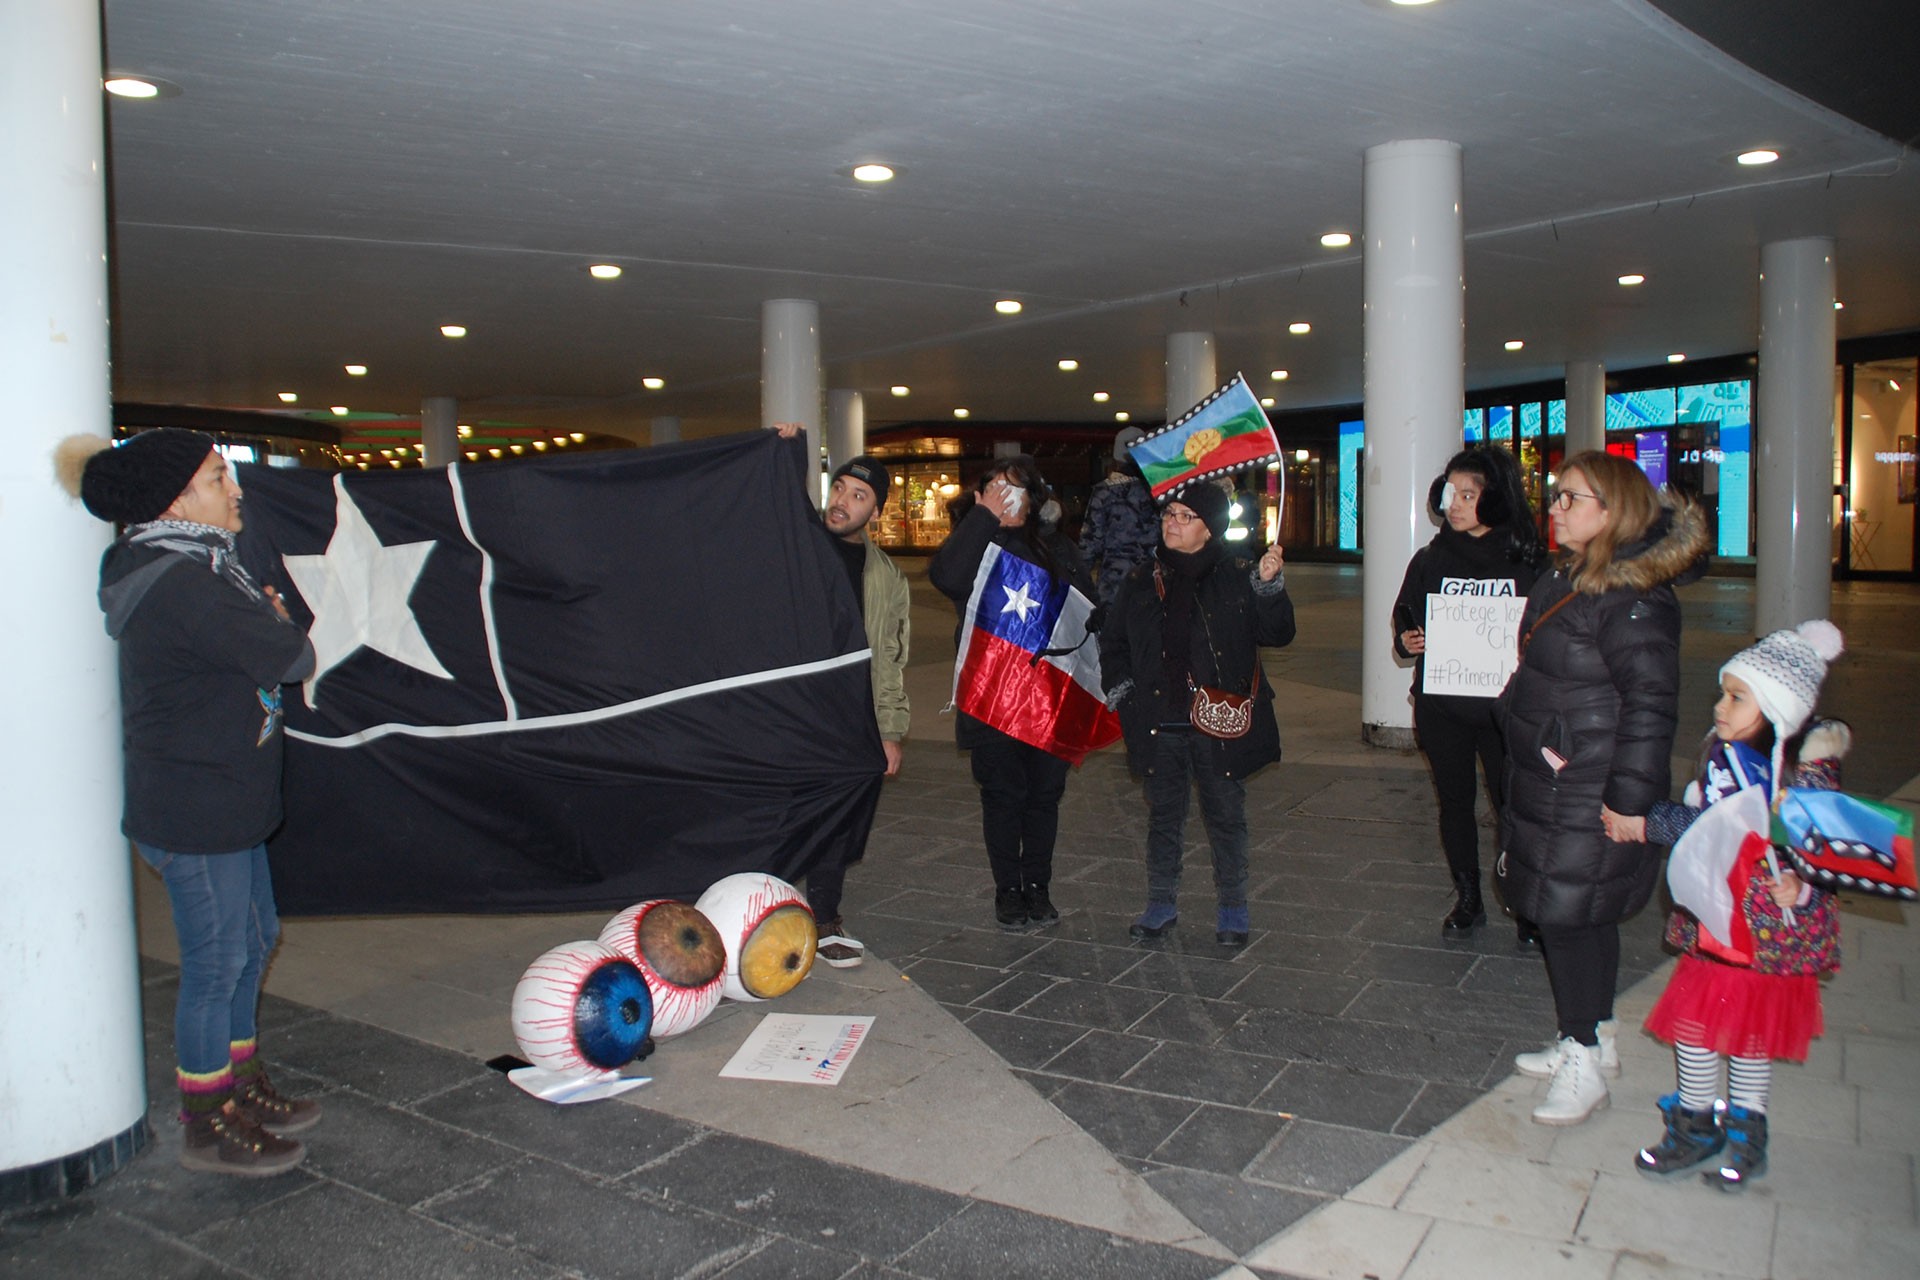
[280,476,453,706]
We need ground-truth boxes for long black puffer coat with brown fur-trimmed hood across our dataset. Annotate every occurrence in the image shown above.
[1496,505,1707,925]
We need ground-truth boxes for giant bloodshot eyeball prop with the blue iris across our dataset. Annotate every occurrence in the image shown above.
[513,940,653,1073]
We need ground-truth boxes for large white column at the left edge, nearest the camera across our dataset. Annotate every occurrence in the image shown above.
[0,0,148,1207]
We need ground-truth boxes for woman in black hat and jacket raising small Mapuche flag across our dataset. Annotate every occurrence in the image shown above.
[1100,480,1294,946]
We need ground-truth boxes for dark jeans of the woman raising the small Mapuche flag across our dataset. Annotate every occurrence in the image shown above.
[1146,727,1246,908]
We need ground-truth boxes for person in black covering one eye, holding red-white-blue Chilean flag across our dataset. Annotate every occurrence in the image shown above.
[927,455,1092,929]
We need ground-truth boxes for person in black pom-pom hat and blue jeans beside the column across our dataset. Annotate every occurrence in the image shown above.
[58,430,321,1176]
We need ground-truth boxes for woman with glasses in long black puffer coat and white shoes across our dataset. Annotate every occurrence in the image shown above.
[1494,453,1707,1125]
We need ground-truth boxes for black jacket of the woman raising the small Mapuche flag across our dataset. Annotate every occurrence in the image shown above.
[1100,555,1294,777]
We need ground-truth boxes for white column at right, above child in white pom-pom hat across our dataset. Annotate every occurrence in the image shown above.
[1753,238,1834,635]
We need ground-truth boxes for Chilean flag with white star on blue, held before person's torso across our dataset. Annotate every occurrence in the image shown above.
[954,545,1119,764]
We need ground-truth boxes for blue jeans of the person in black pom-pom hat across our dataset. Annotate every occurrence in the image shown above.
[134,841,280,1075]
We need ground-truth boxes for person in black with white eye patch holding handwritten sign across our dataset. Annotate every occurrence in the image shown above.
[1394,445,1546,938]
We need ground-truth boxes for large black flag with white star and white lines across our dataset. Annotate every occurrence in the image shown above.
[240,432,885,915]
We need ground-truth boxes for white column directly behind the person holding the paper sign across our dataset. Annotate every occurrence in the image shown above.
[1359,138,1467,748]
